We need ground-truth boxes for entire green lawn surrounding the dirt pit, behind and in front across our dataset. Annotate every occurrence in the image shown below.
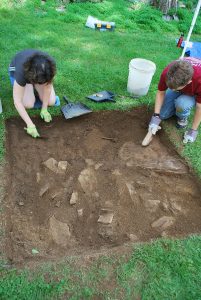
[0,0,201,300]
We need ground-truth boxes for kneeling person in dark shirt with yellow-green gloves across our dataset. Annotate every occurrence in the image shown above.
[9,49,59,138]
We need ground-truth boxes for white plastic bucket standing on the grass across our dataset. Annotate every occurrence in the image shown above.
[127,58,156,97]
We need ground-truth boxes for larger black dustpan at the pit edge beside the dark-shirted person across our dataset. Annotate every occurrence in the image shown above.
[61,96,92,119]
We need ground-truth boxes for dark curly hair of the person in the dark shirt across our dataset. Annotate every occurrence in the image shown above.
[23,54,56,84]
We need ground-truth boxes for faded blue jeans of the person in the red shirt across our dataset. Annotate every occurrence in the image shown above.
[160,89,195,120]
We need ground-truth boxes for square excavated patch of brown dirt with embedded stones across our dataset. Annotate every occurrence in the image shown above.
[3,108,201,263]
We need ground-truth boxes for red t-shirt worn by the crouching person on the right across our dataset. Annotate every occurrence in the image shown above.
[158,57,201,103]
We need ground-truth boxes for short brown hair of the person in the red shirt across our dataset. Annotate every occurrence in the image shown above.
[166,60,194,90]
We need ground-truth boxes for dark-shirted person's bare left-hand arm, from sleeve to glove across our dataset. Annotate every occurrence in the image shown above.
[13,81,34,126]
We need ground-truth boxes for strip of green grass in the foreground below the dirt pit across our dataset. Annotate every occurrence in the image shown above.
[0,236,201,300]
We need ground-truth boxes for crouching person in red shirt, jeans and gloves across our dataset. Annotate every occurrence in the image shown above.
[149,57,201,143]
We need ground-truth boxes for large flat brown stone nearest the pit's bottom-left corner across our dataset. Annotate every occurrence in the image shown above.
[49,216,71,247]
